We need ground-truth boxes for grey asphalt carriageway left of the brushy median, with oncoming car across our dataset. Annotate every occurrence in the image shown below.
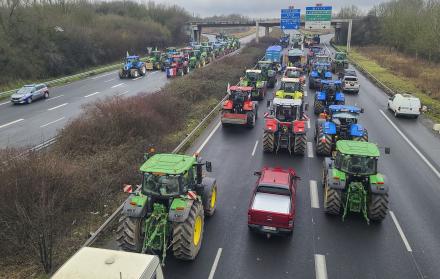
[0,29,264,148]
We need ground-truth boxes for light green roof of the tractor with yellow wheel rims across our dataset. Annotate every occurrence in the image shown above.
[140,154,196,174]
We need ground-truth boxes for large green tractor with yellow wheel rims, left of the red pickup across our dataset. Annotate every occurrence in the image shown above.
[117,150,217,264]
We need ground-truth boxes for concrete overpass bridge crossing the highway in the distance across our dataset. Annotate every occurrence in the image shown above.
[188,18,353,51]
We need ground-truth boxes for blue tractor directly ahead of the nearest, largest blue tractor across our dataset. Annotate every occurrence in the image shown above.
[313,80,345,114]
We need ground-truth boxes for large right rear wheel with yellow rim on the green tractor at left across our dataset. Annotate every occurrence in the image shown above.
[173,201,205,261]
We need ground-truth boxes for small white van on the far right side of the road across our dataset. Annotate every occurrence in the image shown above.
[388,94,422,118]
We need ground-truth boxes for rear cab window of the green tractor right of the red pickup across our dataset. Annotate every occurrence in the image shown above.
[336,154,377,175]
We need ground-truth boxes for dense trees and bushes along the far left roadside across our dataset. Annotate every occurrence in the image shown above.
[0,0,190,87]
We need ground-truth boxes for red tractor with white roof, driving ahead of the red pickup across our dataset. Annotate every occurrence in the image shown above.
[263,98,307,155]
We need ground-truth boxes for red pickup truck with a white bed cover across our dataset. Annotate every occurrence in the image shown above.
[248,167,299,237]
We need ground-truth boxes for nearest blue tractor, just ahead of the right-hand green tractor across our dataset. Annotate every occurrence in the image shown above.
[314,105,368,156]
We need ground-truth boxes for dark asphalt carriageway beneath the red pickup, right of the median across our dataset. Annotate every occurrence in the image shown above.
[150,34,440,279]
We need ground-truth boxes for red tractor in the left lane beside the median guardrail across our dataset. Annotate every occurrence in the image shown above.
[221,86,258,128]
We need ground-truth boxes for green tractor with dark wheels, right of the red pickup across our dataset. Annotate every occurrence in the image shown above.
[322,140,390,224]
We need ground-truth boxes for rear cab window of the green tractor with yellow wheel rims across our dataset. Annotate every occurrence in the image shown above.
[142,173,179,196]
